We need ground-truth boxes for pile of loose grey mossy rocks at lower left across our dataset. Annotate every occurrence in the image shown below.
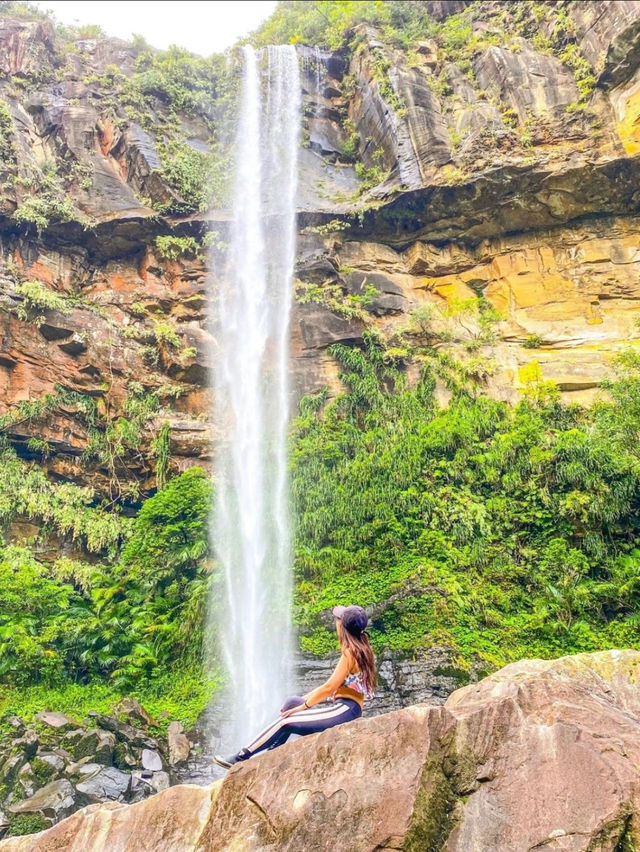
[0,698,196,834]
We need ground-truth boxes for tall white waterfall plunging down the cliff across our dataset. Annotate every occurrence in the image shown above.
[211,45,301,747]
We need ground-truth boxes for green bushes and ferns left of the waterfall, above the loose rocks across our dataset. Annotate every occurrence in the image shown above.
[0,466,211,703]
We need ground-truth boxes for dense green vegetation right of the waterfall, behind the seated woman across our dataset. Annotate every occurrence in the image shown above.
[293,337,640,668]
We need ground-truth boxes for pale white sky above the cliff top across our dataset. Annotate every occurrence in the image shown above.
[35,0,276,56]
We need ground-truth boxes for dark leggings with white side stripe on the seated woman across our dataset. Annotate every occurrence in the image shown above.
[239,698,362,760]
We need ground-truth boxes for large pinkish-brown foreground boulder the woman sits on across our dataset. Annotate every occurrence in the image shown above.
[0,651,640,852]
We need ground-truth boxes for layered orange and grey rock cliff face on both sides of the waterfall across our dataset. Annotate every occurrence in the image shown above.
[0,2,640,512]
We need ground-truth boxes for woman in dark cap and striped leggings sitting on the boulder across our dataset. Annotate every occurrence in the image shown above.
[214,606,377,769]
